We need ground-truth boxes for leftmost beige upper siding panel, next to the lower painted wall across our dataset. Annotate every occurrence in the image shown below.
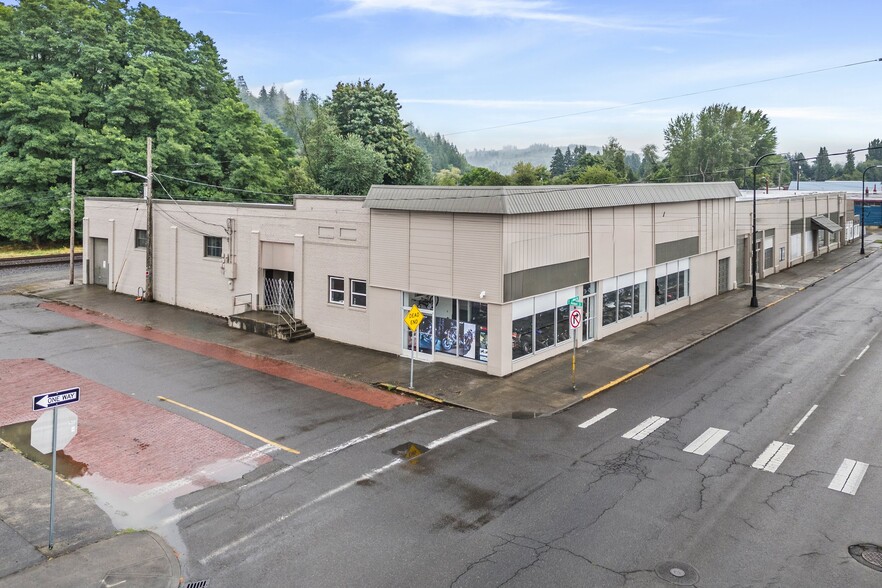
[370,210,410,290]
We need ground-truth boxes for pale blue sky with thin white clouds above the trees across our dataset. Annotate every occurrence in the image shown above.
[147,0,882,161]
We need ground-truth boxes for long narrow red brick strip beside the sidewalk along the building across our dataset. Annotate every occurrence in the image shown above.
[40,302,413,409]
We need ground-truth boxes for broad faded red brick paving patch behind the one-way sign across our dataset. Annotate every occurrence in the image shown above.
[0,359,271,486]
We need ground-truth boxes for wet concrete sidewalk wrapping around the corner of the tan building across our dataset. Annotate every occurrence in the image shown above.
[30,236,880,418]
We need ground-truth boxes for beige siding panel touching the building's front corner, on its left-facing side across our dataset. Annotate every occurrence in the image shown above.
[453,214,502,302]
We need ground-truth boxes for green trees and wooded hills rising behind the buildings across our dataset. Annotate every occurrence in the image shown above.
[0,0,882,246]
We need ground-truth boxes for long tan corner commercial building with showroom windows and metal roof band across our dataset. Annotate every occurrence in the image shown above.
[83,182,844,376]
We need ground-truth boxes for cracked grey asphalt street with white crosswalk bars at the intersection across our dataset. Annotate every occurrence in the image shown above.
[0,256,882,588]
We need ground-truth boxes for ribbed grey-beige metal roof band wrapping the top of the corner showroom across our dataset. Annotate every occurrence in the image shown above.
[364,182,739,214]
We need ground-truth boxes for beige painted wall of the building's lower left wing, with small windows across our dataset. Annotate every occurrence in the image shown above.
[84,197,373,346]
